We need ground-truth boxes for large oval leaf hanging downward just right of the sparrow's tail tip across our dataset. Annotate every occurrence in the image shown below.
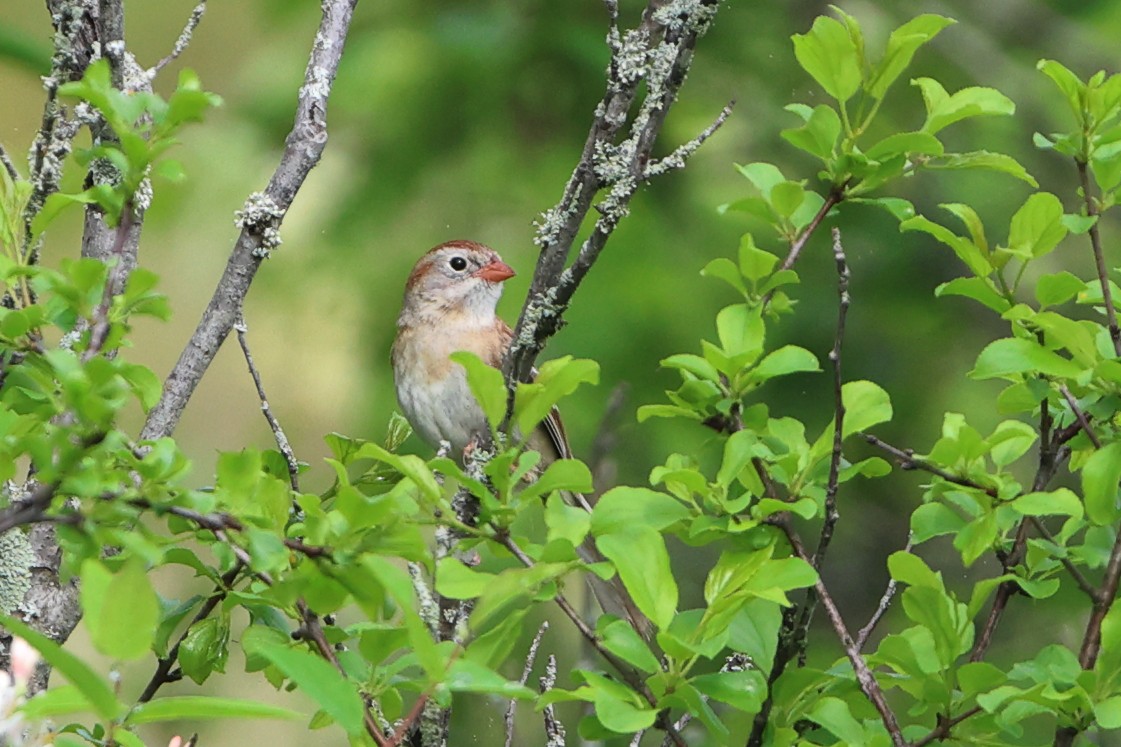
[593,522,677,629]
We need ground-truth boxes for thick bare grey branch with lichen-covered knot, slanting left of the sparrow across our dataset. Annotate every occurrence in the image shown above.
[140,0,358,440]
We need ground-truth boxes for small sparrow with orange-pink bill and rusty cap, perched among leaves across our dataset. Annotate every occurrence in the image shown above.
[392,240,650,636]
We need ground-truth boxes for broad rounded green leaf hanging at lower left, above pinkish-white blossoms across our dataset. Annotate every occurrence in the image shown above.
[82,560,159,661]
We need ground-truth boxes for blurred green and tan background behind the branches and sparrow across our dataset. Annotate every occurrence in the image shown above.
[0,0,1121,745]
